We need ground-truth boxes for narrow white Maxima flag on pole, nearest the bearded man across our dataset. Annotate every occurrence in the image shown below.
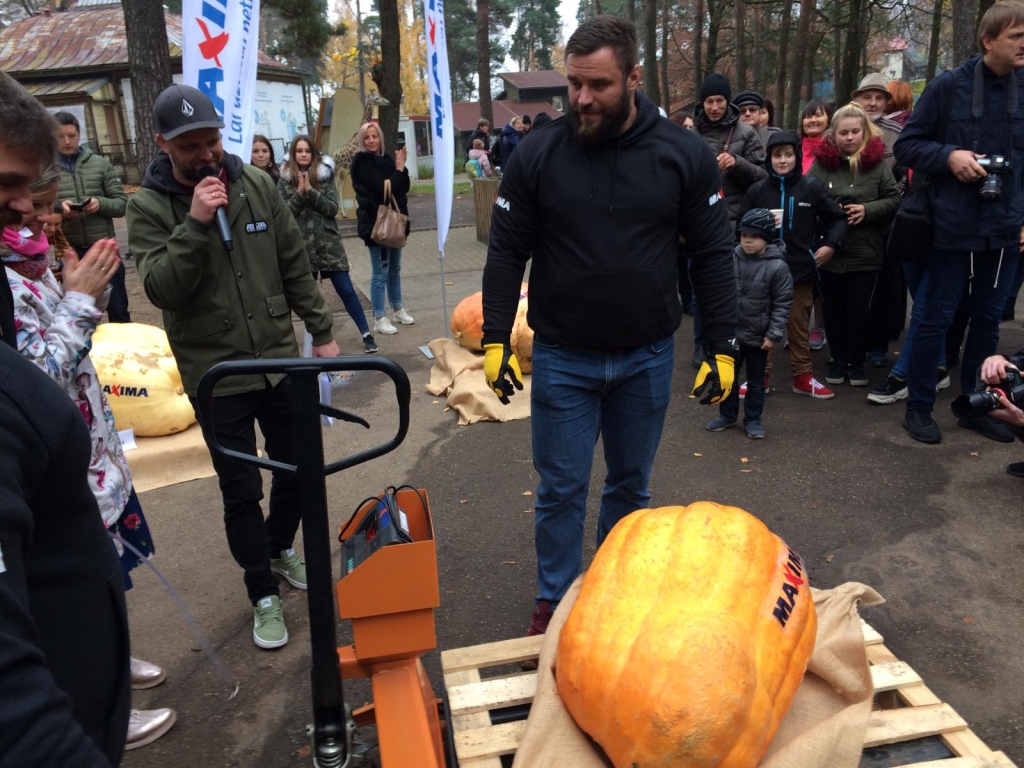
[423,0,455,252]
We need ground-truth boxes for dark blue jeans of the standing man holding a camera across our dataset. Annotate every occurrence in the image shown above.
[906,247,1019,412]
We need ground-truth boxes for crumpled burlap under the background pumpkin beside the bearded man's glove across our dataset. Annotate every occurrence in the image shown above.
[427,339,530,426]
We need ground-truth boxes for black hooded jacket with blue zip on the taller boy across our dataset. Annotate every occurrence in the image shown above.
[739,131,847,283]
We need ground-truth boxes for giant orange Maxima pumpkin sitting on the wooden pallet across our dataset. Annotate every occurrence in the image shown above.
[555,502,817,768]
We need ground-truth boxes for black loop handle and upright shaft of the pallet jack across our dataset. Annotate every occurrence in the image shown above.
[196,356,412,768]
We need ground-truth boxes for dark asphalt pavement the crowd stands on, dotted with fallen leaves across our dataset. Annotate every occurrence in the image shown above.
[116,227,1024,768]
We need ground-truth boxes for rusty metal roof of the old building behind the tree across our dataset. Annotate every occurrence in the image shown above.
[0,3,284,75]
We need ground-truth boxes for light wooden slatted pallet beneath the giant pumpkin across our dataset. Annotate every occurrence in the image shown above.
[441,624,1016,768]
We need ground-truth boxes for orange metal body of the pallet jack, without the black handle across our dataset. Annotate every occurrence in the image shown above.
[337,488,444,768]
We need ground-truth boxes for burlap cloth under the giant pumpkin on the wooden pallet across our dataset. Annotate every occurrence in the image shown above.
[512,577,885,768]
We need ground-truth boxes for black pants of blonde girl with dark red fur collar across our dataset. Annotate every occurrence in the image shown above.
[821,271,879,366]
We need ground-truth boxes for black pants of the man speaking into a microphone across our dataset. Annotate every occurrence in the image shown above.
[190,379,302,604]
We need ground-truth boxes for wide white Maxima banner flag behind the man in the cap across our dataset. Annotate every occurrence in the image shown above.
[181,0,259,163]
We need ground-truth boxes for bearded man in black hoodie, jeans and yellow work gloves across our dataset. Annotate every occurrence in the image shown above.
[483,15,736,634]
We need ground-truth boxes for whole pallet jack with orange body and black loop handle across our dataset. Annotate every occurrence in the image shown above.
[197,357,458,768]
